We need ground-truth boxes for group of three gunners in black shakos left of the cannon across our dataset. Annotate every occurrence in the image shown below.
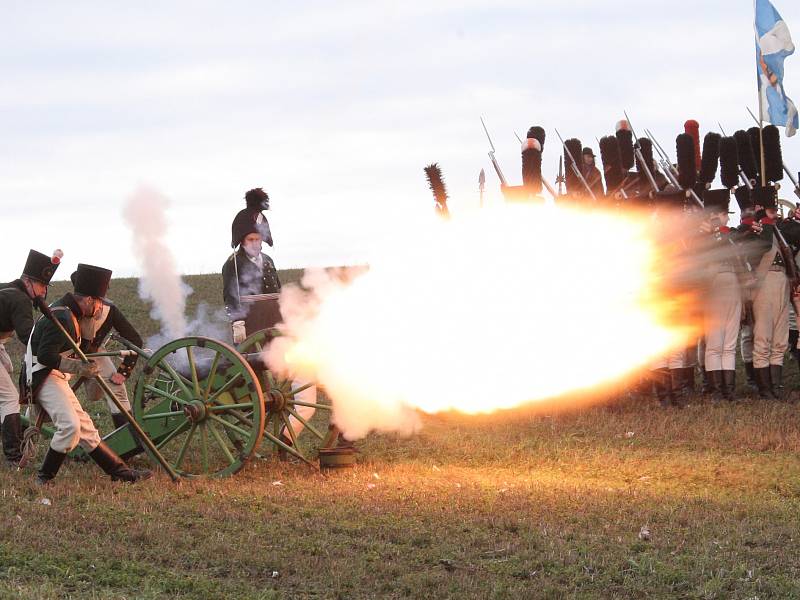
[0,250,151,484]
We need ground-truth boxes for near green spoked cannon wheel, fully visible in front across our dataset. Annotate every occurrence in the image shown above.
[133,337,265,477]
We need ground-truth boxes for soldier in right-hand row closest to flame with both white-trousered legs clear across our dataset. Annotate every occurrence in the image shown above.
[701,189,742,400]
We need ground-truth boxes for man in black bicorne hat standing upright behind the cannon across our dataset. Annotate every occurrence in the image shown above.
[222,213,281,344]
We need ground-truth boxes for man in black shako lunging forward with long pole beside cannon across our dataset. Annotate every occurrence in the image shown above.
[24,264,151,484]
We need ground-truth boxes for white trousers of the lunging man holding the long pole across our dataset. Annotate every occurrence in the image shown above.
[36,371,100,453]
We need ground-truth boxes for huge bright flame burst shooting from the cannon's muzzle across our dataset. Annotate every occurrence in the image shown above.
[267,205,694,438]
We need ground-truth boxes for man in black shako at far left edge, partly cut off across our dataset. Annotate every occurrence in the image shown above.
[0,250,61,465]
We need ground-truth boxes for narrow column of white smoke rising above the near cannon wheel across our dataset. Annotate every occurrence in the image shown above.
[123,186,192,339]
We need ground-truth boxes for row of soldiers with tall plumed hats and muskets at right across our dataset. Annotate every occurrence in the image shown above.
[495,120,800,407]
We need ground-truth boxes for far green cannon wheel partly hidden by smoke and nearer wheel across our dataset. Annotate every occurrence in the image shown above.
[237,329,332,466]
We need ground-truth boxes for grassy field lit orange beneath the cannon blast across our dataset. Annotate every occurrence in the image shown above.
[0,272,800,599]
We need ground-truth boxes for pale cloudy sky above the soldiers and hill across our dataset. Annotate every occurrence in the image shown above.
[0,0,800,281]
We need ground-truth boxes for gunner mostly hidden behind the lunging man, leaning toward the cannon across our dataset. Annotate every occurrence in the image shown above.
[70,271,143,436]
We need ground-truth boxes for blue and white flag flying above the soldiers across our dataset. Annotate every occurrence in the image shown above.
[755,0,800,136]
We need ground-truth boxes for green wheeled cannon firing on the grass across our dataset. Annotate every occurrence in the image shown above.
[19,329,346,478]
